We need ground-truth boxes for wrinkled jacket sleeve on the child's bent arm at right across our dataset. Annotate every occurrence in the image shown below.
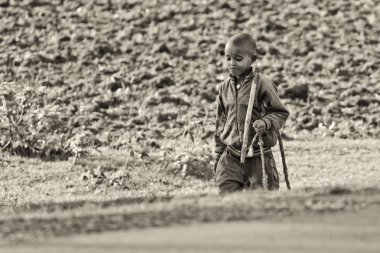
[260,74,289,132]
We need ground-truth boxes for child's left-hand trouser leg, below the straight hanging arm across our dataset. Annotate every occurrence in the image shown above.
[216,150,244,193]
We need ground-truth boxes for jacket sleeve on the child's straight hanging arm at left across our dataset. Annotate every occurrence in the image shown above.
[214,87,226,160]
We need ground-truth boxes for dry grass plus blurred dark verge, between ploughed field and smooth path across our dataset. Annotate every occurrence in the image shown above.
[0,136,380,240]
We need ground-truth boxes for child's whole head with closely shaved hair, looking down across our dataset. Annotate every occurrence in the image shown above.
[224,33,256,76]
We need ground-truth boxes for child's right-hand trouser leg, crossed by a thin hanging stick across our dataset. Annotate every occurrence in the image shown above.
[244,152,280,190]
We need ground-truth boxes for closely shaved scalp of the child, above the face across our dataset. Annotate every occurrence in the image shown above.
[225,33,256,58]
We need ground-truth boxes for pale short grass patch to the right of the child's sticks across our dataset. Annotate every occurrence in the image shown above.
[277,139,380,189]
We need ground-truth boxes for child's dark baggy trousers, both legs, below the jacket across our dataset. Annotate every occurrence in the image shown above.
[216,149,280,193]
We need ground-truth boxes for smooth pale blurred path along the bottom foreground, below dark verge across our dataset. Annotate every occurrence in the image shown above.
[0,207,380,253]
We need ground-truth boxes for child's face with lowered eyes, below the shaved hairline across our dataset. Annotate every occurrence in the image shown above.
[224,43,254,76]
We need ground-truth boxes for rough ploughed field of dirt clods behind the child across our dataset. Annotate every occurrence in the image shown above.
[0,0,380,156]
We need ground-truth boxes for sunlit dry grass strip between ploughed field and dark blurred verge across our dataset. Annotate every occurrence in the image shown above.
[0,139,380,207]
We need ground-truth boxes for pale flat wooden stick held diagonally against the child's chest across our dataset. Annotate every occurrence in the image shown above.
[240,71,259,163]
